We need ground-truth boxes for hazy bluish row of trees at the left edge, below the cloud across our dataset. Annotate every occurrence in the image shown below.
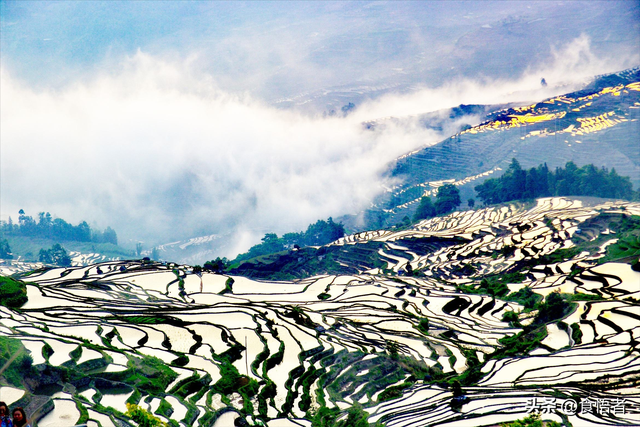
[0,209,118,245]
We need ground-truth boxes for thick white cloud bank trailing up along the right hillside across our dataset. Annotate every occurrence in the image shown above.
[0,38,636,256]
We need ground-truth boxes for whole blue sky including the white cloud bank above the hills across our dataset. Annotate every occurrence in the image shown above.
[0,0,640,255]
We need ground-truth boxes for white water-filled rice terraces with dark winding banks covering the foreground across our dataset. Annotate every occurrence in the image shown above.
[0,198,640,427]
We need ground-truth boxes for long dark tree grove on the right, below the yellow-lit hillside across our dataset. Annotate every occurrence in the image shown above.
[475,159,638,204]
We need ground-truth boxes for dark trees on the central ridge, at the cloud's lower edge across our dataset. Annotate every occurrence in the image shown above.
[233,218,345,263]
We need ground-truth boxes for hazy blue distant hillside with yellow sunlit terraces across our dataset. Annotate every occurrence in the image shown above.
[377,68,640,224]
